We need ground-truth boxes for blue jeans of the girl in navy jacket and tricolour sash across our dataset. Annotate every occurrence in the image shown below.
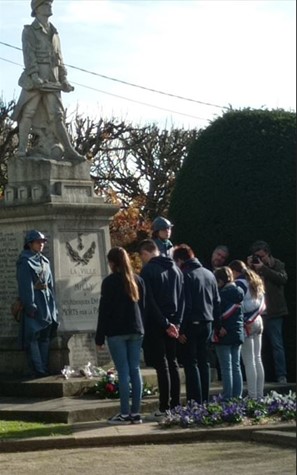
[216,345,242,400]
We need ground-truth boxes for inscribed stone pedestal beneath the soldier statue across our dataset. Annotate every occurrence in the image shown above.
[0,157,117,374]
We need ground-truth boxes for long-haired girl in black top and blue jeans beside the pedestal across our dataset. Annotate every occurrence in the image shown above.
[95,247,145,424]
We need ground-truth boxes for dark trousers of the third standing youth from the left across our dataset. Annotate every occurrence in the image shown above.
[181,322,212,404]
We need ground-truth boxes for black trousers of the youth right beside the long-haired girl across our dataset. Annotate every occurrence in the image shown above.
[144,330,180,412]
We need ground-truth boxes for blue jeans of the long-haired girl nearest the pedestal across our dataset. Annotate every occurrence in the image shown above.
[107,334,143,415]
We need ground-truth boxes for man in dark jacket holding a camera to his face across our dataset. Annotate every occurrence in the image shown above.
[247,241,288,384]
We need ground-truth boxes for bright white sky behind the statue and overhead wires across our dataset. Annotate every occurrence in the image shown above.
[0,0,296,128]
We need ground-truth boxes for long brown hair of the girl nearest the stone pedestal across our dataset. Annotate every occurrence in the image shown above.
[107,247,139,302]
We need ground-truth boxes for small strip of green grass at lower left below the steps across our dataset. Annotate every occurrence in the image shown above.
[0,421,72,439]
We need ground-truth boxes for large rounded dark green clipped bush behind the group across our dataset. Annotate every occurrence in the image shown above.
[169,109,296,384]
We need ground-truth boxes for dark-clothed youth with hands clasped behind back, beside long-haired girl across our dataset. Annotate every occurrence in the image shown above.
[139,239,184,419]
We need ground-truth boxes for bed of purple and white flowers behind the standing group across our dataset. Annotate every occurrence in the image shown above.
[160,391,296,427]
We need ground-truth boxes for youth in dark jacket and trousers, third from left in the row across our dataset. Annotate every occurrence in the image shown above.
[173,244,220,404]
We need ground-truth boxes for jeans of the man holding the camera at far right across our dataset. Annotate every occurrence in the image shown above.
[263,316,287,378]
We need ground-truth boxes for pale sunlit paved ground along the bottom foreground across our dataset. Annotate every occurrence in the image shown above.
[0,441,296,475]
